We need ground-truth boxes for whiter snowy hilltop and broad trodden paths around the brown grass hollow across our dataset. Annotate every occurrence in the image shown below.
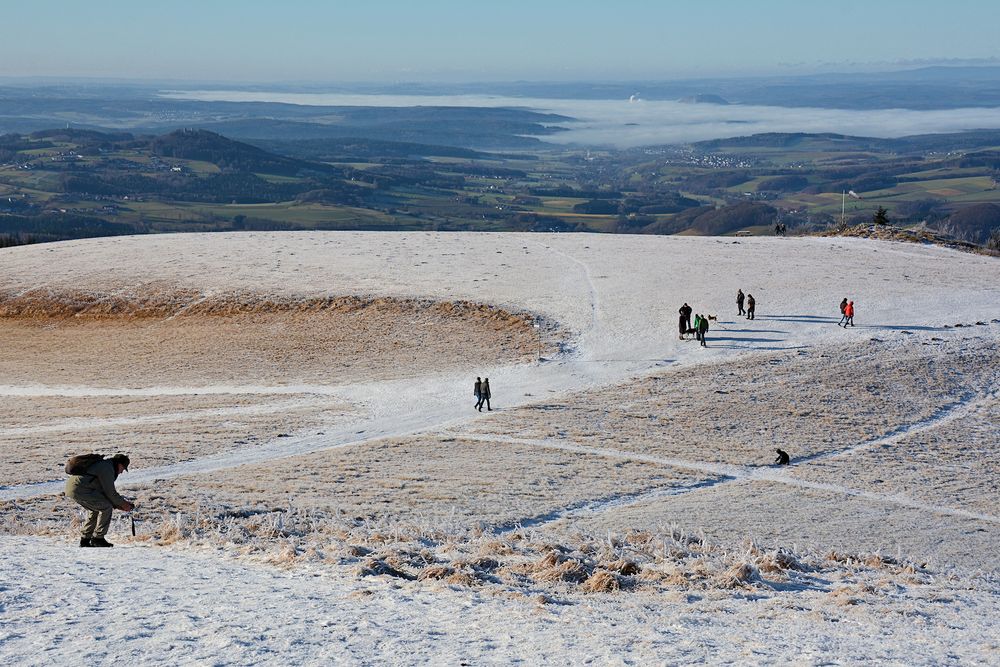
[0,233,1000,500]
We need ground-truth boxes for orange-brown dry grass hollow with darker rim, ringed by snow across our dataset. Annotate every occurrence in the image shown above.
[0,285,557,387]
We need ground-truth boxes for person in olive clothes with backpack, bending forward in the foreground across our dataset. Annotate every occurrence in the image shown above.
[66,454,135,547]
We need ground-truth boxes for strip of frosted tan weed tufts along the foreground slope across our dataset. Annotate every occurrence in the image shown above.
[0,507,934,605]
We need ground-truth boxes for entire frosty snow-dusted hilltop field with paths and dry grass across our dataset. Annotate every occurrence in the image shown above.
[0,232,1000,665]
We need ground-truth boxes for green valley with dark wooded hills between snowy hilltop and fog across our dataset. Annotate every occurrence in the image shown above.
[0,124,1000,249]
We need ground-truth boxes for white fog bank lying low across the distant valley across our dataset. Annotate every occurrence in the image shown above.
[164,90,1000,148]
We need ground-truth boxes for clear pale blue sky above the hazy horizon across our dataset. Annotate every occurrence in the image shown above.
[0,0,1000,82]
